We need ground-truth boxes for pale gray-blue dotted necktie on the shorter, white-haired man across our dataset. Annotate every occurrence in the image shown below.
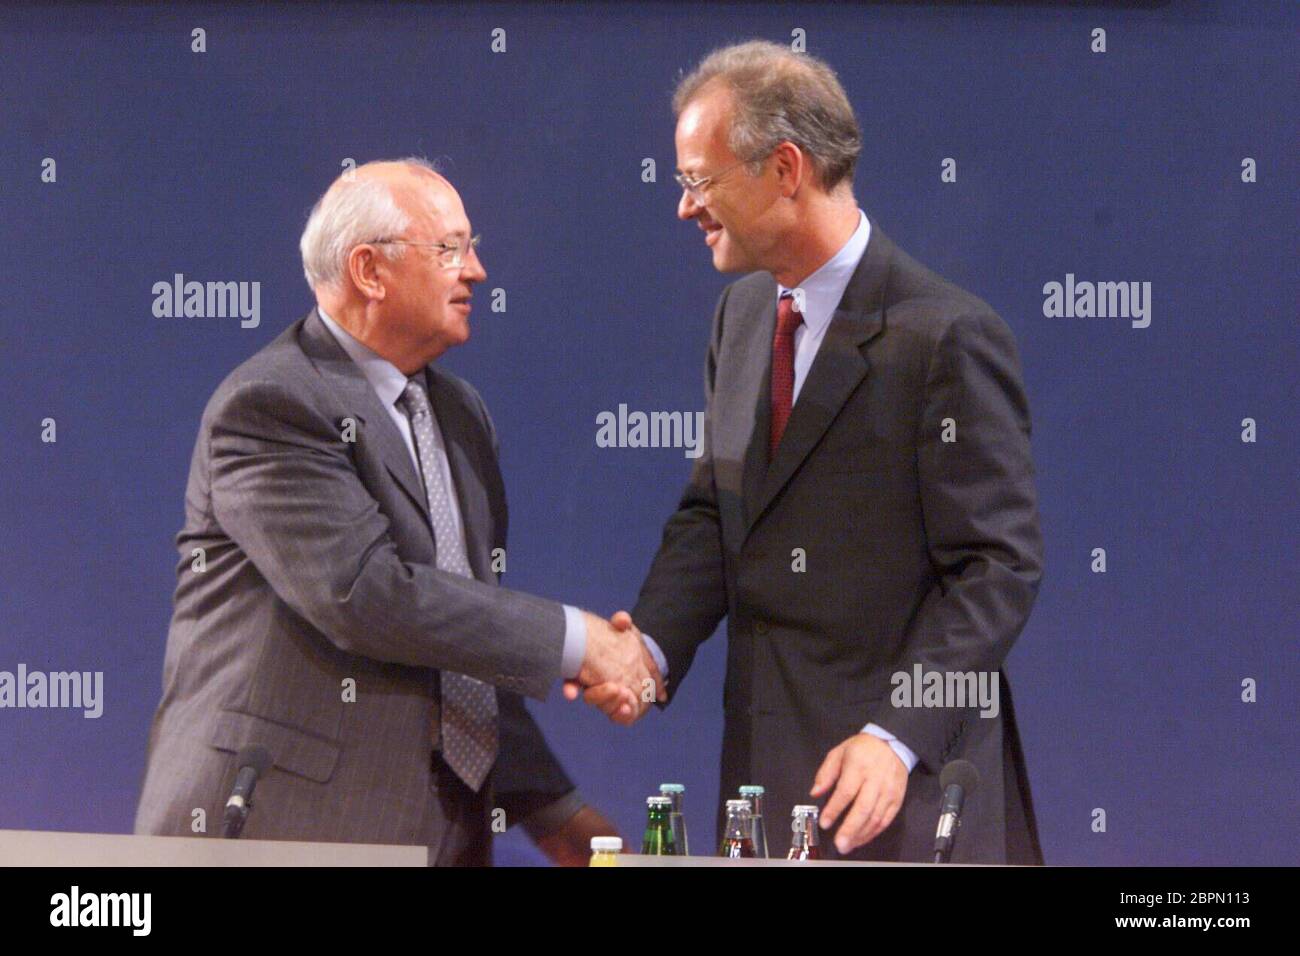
[398,372,497,792]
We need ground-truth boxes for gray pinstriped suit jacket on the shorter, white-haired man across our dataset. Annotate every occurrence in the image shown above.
[135,311,573,848]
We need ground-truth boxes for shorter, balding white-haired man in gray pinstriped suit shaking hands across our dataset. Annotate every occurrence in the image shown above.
[135,160,663,865]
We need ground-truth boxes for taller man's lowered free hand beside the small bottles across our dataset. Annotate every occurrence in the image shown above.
[810,734,907,853]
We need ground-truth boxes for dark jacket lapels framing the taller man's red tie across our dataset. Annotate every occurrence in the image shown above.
[745,220,893,533]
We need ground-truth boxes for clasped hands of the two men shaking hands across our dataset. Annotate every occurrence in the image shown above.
[564,611,668,727]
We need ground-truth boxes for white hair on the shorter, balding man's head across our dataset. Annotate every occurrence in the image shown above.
[298,156,438,289]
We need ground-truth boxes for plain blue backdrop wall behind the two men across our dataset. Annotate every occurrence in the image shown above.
[0,3,1300,864]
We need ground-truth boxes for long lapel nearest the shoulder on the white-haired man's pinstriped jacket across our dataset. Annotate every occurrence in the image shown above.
[300,308,432,527]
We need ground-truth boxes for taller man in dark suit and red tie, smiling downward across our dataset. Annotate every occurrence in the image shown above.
[585,42,1043,862]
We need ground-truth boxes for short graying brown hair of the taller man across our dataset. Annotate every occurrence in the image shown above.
[672,40,862,193]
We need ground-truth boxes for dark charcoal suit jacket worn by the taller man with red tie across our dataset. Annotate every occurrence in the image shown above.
[633,220,1043,862]
